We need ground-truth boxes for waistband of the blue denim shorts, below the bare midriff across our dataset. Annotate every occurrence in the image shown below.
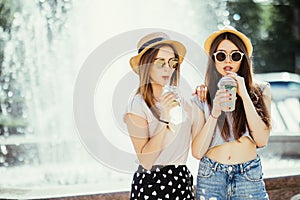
[201,155,261,174]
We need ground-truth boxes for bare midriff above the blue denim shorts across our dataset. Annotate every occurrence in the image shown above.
[206,137,257,165]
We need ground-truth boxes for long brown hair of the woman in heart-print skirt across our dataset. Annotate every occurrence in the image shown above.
[137,44,180,119]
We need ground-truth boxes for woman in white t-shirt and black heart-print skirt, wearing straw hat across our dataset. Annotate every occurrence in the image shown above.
[124,32,198,200]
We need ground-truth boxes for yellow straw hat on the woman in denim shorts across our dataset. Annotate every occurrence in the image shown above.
[204,26,253,57]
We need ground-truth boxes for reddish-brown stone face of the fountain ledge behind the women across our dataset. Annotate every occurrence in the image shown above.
[41,175,300,200]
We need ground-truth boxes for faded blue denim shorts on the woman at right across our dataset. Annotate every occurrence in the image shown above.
[196,156,269,200]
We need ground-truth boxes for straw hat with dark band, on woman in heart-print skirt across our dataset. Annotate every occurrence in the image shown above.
[130,32,186,73]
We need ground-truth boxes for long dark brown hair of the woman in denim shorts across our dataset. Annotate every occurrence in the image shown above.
[205,33,271,141]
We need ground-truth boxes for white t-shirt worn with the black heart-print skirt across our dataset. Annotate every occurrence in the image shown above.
[125,94,192,165]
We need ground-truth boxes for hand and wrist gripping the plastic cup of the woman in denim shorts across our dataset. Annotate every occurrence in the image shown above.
[211,90,231,118]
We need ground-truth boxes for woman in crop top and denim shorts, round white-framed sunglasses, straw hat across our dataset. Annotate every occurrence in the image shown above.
[192,27,271,200]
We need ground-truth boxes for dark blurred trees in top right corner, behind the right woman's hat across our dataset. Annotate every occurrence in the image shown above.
[227,0,300,73]
